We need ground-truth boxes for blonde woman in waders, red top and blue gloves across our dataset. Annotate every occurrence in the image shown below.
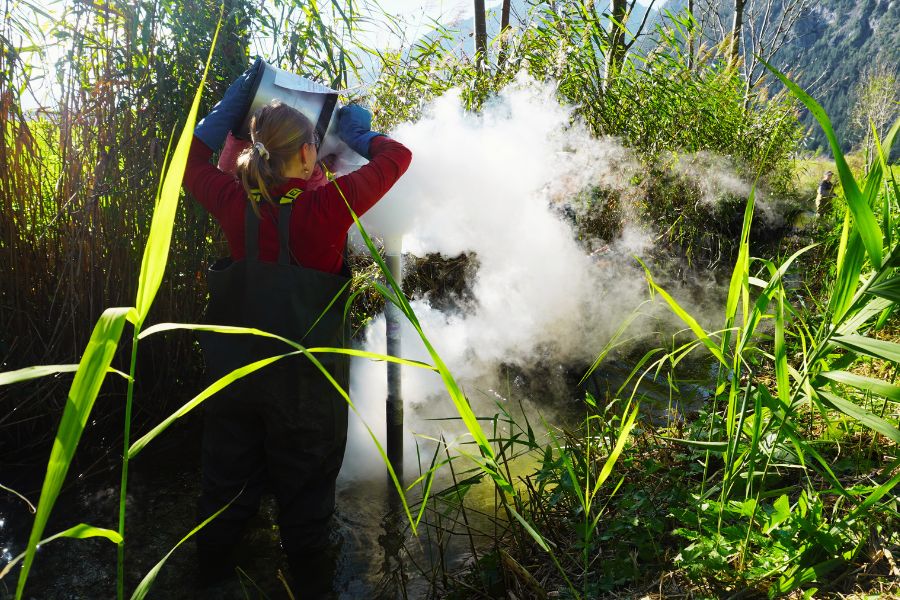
[184,61,411,598]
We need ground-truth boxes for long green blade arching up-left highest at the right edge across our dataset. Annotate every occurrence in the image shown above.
[760,61,883,269]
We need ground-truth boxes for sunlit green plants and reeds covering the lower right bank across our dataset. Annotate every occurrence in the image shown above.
[384,73,900,597]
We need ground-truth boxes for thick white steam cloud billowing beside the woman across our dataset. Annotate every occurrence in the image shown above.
[342,79,768,479]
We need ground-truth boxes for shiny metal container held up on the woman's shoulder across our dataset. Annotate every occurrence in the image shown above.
[237,62,350,162]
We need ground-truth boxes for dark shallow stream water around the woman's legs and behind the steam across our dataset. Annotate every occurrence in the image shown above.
[0,356,709,600]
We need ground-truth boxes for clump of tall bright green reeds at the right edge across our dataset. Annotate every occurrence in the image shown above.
[647,67,900,593]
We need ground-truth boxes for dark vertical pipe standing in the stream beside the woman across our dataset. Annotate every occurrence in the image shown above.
[384,244,403,482]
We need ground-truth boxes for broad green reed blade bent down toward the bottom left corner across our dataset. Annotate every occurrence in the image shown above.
[16,308,133,600]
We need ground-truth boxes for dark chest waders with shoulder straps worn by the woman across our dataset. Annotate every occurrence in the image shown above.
[198,189,349,590]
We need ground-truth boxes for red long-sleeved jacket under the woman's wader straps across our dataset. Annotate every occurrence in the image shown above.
[182,136,412,273]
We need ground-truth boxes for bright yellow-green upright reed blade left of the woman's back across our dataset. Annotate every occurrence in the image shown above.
[135,16,222,329]
